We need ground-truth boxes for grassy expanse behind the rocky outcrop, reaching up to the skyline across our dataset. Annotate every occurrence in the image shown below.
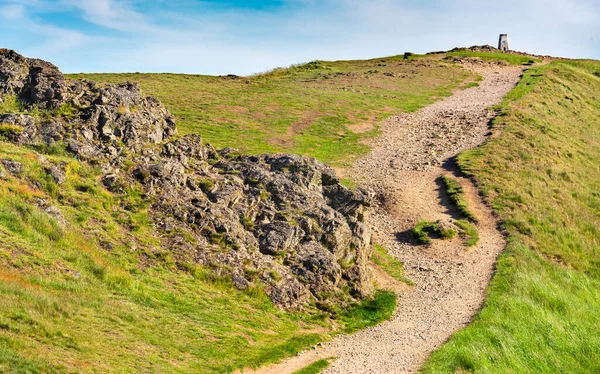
[70,56,473,167]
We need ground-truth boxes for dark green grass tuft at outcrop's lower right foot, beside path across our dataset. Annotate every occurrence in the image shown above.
[340,290,397,334]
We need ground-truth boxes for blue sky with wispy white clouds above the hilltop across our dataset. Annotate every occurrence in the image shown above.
[0,0,600,75]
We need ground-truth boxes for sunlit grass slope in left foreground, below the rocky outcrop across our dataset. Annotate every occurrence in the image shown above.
[0,137,396,373]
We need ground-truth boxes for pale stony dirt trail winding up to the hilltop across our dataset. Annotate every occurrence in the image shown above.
[258,64,522,374]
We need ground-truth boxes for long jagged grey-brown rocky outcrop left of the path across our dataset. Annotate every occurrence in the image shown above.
[0,50,372,309]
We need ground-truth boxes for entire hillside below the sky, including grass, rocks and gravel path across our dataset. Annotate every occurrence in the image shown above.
[0,47,600,373]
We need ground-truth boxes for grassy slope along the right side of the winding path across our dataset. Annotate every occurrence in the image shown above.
[425,61,600,373]
